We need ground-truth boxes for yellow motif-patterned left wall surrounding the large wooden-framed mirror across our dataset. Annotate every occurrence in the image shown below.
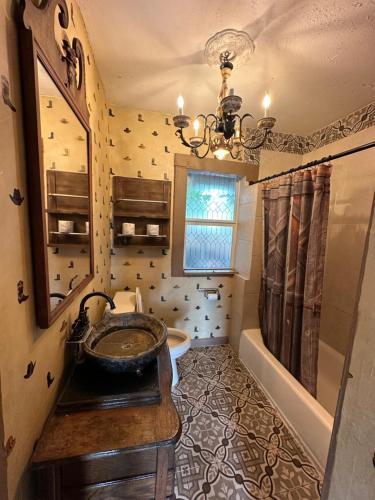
[0,0,110,498]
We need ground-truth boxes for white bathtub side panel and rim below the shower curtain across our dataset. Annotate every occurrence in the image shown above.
[239,330,333,470]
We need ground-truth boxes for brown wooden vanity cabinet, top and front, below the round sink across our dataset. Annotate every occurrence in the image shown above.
[32,345,181,500]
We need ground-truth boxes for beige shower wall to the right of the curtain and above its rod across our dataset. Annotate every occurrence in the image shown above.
[303,127,375,354]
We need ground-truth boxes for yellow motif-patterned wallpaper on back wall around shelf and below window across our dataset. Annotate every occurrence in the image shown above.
[109,108,233,344]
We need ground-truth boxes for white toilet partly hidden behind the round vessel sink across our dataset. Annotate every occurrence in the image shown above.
[106,287,191,386]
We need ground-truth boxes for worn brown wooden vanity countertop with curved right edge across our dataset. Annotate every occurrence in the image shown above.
[32,344,181,468]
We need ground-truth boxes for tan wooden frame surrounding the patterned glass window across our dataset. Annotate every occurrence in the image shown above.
[171,154,259,277]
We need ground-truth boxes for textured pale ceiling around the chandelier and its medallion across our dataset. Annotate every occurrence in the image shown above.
[78,0,375,135]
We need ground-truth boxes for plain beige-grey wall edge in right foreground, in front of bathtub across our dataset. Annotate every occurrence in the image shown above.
[324,202,375,500]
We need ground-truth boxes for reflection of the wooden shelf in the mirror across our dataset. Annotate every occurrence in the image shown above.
[45,170,89,248]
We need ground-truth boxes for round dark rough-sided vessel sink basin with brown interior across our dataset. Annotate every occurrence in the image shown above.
[83,313,168,373]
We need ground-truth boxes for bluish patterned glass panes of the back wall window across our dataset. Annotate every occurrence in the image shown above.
[184,171,237,272]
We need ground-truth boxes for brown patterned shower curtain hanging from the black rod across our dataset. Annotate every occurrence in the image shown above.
[259,165,330,397]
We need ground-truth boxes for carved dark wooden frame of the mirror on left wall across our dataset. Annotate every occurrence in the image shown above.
[18,0,94,328]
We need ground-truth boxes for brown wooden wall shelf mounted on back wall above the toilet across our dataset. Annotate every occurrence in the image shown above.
[113,176,171,248]
